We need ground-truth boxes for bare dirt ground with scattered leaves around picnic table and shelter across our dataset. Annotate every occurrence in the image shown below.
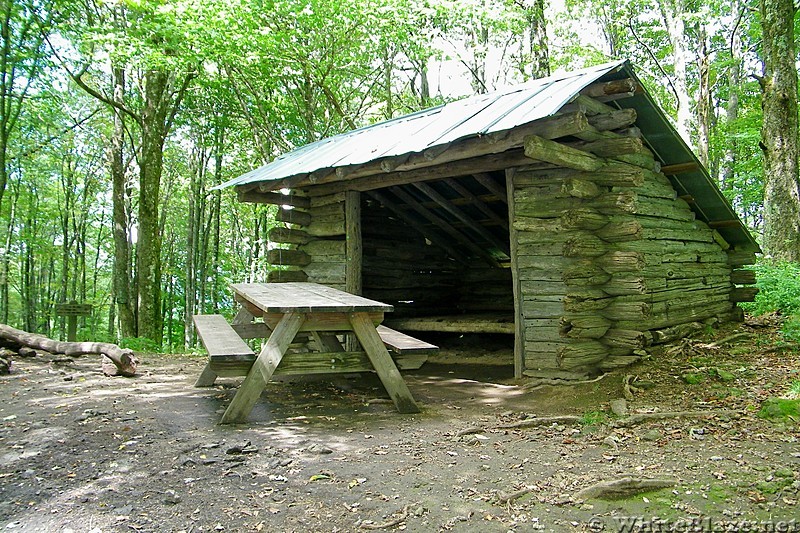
[0,318,800,532]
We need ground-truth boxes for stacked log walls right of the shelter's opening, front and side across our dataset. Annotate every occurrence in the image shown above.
[507,97,753,378]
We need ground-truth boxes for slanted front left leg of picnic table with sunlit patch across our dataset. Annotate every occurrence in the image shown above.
[220,313,306,424]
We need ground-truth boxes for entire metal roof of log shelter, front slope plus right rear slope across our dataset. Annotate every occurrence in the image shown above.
[222,60,760,252]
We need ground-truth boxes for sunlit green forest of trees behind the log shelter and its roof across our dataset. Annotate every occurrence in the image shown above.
[0,0,800,351]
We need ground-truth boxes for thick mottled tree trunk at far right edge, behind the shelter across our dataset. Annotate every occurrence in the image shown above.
[760,0,800,261]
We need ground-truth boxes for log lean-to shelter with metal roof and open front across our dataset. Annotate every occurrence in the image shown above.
[223,61,759,379]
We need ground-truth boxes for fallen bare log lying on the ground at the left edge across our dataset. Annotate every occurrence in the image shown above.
[0,324,138,376]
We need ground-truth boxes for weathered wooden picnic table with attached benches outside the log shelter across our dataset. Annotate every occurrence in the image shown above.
[194,282,438,424]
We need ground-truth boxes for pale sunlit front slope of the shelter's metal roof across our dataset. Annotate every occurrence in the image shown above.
[220,61,625,188]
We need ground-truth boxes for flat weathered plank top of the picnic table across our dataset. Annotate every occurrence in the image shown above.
[231,282,394,313]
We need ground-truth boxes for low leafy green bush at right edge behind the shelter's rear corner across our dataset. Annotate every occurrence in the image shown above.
[741,261,800,315]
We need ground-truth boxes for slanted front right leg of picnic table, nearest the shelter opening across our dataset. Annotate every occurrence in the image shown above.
[349,313,419,413]
